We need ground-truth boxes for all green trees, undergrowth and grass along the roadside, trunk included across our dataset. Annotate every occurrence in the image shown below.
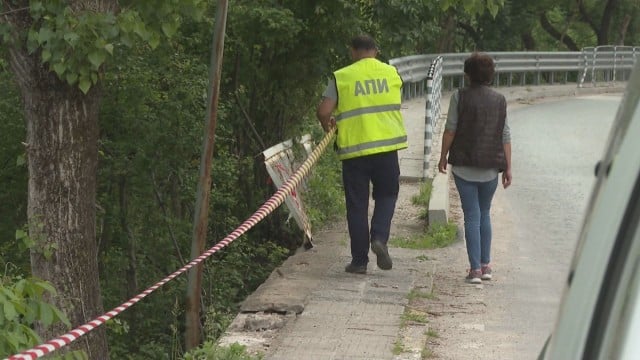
[0,0,640,360]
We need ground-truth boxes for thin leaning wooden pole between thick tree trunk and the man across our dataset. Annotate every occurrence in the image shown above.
[185,0,228,350]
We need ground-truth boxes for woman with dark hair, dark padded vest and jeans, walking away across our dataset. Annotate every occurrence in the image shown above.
[438,53,511,284]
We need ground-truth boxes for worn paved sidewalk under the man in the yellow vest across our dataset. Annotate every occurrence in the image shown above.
[220,84,624,360]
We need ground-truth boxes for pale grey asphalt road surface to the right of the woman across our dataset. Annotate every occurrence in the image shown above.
[486,95,620,359]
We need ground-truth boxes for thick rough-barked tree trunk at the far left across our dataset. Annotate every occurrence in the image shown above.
[10,43,108,359]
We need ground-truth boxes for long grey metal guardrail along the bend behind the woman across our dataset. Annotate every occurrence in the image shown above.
[389,46,640,99]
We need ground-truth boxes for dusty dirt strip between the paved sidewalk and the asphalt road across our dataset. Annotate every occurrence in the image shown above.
[394,175,514,360]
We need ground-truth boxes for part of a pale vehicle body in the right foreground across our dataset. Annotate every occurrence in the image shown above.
[539,62,640,360]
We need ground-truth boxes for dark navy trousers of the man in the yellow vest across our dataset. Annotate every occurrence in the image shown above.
[342,151,400,265]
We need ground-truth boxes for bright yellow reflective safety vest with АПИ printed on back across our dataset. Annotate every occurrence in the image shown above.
[334,58,407,160]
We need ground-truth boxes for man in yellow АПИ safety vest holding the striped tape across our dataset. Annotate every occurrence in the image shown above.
[316,35,407,274]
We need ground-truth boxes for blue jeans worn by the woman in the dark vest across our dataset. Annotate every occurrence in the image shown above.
[453,174,498,270]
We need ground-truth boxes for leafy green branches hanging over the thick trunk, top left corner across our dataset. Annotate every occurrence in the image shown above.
[0,0,204,94]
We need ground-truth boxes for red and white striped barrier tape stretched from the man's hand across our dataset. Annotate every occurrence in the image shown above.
[5,129,335,360]
